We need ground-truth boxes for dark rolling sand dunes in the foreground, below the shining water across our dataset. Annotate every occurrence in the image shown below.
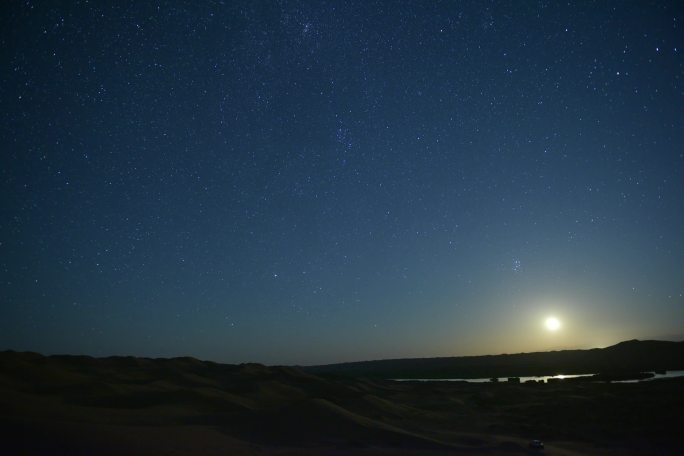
[0,352,684,455]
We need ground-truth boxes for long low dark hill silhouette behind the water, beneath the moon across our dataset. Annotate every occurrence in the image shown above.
[303,339,684,379]
